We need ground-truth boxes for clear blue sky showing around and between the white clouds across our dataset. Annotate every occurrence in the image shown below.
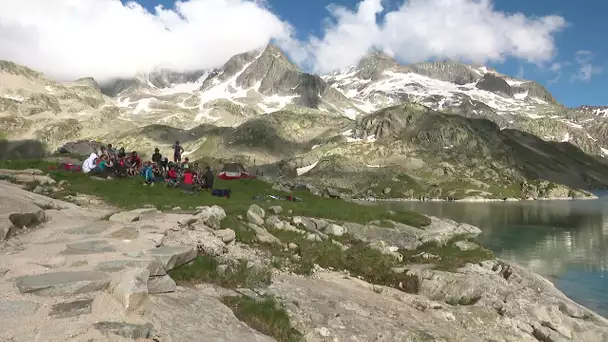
[128,0,608,106]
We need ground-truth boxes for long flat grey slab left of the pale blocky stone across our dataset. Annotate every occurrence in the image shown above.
[15,271,111,297]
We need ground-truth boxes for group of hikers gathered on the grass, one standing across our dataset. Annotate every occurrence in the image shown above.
[81,141,214,190]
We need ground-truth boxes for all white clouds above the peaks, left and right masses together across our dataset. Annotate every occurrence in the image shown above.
[0,0,566,81]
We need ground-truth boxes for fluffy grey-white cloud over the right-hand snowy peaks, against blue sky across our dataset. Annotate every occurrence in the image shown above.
[308,0,566,71]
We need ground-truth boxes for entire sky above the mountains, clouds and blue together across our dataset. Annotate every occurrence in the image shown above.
[0,0,608,107]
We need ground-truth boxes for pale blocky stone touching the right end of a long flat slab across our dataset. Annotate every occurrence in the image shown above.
[112,268,150,314]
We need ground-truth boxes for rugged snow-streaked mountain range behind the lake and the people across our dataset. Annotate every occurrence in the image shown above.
[0,45,608,198]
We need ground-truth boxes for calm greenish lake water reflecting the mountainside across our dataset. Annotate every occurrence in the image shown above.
[386,198,608,317]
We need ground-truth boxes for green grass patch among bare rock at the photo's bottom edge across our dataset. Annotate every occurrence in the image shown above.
[222,296,304,342]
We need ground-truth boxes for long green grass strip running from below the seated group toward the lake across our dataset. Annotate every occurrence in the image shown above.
[0,160,430,227]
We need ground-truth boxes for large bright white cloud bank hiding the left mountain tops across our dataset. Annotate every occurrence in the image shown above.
[0,0,291,80]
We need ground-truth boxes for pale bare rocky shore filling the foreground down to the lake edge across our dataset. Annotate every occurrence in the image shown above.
[0,174,608,342]
